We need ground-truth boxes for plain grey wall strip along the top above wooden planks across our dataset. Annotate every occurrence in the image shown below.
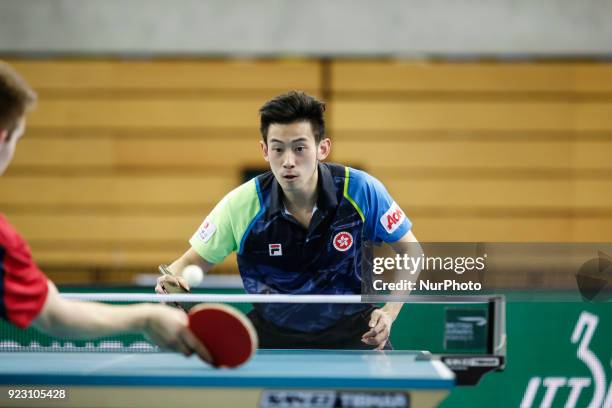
[0,0,612,59]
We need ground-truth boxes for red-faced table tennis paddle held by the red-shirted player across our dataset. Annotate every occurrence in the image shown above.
[189,303,258,368]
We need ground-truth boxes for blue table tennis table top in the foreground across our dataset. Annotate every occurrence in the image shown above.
[0,350,455,389]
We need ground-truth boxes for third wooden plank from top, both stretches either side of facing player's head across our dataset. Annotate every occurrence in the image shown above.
[15,135,612,172]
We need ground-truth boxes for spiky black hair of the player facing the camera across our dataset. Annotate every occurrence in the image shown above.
[259,91,325,144]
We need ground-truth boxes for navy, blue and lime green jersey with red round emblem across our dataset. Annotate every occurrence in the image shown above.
[190,163,411,332]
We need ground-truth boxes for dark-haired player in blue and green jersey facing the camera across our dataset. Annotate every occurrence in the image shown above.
[156,91,416,349]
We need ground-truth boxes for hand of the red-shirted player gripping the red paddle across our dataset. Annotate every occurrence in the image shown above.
[143,305,213,364]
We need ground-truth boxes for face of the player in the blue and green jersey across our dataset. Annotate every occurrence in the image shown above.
[261,122,331,193]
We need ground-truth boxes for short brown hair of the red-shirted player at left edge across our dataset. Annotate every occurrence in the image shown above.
[0,61,36,135]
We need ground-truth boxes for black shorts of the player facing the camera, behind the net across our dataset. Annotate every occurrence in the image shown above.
[247,306,393,350]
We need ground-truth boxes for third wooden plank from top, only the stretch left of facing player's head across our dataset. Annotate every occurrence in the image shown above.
[10,132,266,169]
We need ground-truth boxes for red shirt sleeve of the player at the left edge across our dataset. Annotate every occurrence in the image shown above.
[0,214,48,328]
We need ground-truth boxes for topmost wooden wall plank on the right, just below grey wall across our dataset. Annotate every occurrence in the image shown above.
[331,61,612,93]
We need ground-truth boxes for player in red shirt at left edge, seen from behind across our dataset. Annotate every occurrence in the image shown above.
[0,61,211,362]
